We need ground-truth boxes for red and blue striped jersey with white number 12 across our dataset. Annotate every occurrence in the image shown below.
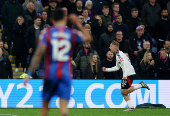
[39,26,83,79]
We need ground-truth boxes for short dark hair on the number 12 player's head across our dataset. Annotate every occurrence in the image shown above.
[51,8,64,21]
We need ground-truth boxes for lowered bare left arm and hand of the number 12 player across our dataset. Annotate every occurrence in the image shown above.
[24,45,46,85]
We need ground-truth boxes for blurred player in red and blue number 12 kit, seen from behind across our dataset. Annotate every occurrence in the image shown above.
[24,9,92,116]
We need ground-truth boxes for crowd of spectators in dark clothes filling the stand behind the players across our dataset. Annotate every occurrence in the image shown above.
[0,0,170,79]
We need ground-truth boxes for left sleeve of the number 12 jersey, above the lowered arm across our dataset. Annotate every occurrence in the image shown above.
[38,30,47,46]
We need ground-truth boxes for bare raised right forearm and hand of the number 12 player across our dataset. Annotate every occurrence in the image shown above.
[69,14,92,42]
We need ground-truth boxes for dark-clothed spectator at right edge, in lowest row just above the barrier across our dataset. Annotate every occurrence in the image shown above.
[155,49,170,79]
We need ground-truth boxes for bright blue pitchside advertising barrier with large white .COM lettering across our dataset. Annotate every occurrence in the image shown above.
[0,79,170,108]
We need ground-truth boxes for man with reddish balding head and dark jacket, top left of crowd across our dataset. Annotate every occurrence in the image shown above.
[23,2,37,28]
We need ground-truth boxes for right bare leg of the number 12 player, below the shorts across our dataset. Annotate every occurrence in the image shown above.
[59,98,68,116]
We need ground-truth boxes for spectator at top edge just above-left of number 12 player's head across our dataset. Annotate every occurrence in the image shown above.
[43,0,57,18]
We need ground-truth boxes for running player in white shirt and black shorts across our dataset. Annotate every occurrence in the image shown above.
[103,40,150,111]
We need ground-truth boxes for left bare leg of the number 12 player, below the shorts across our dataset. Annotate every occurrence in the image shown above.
[40,99,49,116]
